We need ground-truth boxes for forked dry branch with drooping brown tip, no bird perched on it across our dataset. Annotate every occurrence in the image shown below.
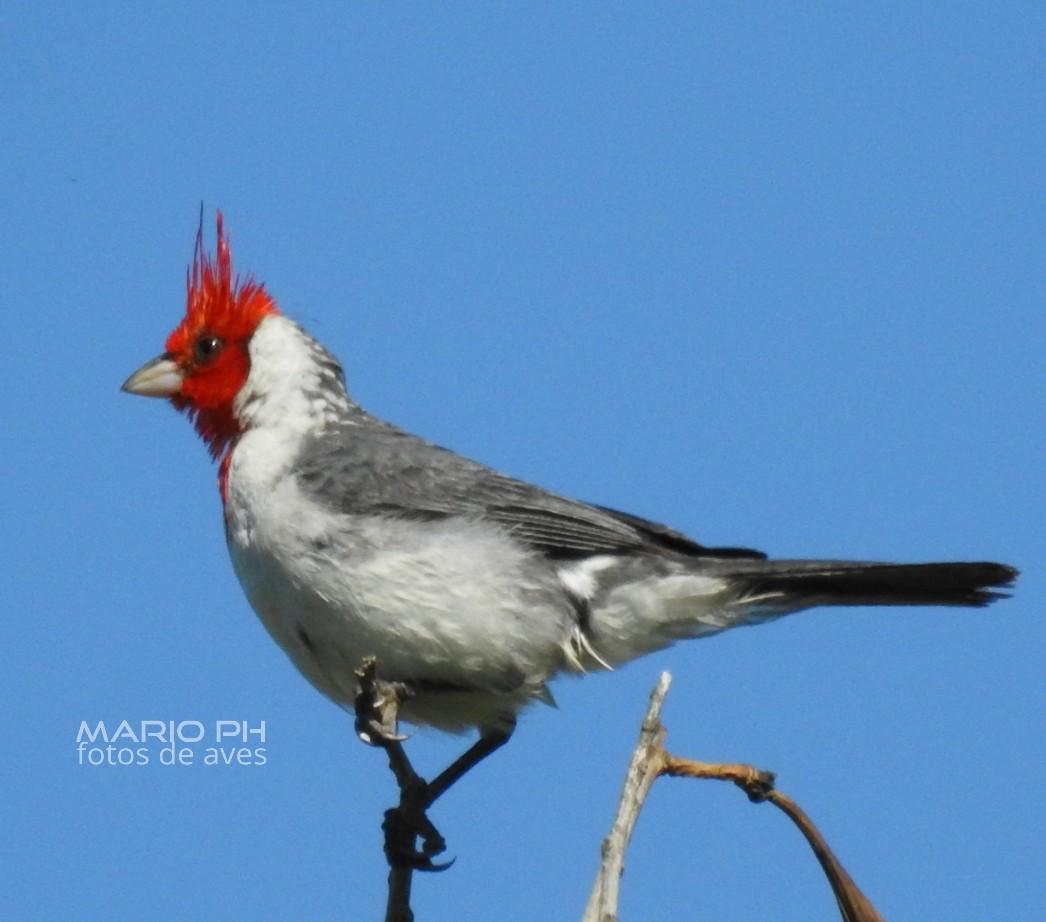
[582,672,883,922]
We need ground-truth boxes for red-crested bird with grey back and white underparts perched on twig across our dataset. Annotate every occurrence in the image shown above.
[122,211,1018,786]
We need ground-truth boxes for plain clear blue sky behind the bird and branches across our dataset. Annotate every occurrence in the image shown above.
[0,2,1046,922]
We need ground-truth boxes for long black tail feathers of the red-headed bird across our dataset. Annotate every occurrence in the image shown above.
[723,560,1018,610]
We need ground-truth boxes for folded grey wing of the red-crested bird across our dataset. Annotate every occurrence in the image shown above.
[296,418,766,559]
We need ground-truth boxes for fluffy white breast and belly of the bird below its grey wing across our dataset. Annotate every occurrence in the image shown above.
[226,466,574,727]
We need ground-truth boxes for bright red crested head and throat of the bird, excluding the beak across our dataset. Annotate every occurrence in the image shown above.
[166,211,279,457]
